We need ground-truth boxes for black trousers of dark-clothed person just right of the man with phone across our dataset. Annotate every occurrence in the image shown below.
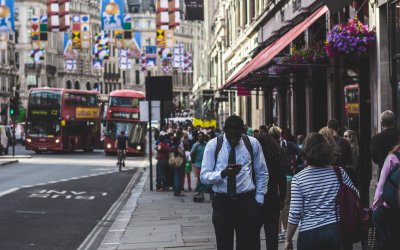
[255,196,280,250]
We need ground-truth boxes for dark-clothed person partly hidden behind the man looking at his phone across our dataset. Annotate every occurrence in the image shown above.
[256,133,286,250]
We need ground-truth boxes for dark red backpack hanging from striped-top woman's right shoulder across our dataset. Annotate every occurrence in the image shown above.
[333,167,369,243]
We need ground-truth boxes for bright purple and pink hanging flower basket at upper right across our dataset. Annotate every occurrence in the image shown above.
[325,16,376,60]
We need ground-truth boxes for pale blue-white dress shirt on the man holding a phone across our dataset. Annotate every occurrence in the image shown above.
[200,135,268,203]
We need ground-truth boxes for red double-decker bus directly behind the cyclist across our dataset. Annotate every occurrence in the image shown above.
[104,89,146,155]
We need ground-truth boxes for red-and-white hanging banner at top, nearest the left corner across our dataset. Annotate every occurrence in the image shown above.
[47,0,70,32]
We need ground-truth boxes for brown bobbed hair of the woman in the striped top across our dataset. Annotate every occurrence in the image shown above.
[301,132,335,167]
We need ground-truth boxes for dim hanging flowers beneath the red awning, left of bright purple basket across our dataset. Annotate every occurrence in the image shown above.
[274,43,328,74]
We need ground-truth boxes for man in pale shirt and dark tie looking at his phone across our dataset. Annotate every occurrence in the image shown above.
[200,115,268,250]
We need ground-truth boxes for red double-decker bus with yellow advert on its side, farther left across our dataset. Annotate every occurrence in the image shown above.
[25,88,102,153]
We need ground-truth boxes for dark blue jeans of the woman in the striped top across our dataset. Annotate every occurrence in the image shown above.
[297,223,343,250]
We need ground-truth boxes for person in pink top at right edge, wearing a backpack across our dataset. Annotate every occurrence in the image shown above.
[372,145,400,250]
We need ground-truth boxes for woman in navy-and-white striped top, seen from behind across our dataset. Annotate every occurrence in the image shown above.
[285,133,358,250]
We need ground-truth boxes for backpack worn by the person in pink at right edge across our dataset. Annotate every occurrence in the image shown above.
[382,153,400,210]
